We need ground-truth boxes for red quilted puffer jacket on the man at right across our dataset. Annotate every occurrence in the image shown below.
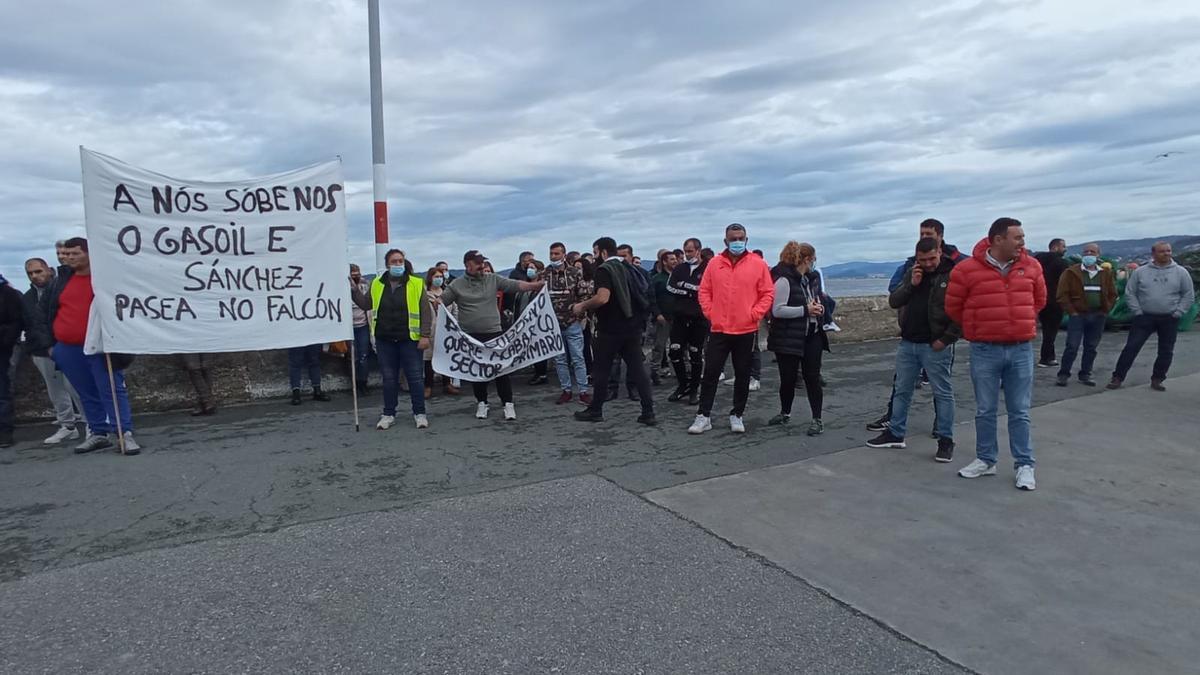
[946,238,1046,342]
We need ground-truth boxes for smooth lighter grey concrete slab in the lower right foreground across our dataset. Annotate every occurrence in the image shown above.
[648,375,1200,674]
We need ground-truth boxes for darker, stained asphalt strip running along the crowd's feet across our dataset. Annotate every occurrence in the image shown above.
[0,333,1200,579]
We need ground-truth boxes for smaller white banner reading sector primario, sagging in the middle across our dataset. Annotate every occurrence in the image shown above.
[433,288,563,382]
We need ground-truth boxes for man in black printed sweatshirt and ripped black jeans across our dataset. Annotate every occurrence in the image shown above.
[667,238,709,406]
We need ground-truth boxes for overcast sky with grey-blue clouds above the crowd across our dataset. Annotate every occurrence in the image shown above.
[0,0,1200,276]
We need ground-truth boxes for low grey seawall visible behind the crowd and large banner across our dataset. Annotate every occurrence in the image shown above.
[13,295,896,422]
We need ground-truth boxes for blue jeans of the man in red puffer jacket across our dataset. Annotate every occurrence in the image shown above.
[969,342,1033,466]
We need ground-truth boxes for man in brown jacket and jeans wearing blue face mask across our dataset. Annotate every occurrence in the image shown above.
[1055,244,1117,387]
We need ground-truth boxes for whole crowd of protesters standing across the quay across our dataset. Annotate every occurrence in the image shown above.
[0,217,1195,490]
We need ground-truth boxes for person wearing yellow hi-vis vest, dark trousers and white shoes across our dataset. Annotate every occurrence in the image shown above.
[371,249,433,430]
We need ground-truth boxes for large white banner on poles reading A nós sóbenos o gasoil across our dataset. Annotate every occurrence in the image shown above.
[79,148,353,354]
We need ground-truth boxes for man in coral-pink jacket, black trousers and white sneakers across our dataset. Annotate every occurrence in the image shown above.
[688,222,775,434]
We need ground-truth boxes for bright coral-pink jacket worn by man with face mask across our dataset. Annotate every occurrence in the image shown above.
[698,251,775,335]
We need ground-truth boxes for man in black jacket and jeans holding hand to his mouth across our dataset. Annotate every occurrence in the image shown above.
[866,237,962,462]
